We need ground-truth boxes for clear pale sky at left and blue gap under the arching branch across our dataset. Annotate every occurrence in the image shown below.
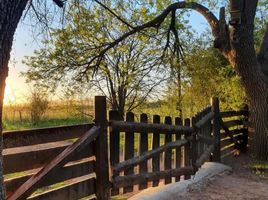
[4,8,207,104]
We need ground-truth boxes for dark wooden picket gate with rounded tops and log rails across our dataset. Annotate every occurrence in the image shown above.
[109,99,220,195]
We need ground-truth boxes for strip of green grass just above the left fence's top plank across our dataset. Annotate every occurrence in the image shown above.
[3,117,92,131]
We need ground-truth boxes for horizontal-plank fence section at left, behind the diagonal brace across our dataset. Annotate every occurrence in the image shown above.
[3,124,95,199]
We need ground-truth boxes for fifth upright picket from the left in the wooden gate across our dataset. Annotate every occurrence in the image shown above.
[164,116,172,184]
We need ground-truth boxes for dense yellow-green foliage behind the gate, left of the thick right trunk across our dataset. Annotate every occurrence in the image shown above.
[137,39,246,118]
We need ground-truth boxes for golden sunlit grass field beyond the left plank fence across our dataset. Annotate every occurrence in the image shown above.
[3,101,93,131]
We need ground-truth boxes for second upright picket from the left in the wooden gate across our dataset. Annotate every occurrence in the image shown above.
[123,112,134,193]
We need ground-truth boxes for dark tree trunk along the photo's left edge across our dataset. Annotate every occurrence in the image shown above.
[0,0,28,199]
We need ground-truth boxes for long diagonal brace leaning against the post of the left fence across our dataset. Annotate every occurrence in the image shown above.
[7,126,99,200]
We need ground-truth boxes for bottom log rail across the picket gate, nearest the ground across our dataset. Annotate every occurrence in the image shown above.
[112,167,194,187]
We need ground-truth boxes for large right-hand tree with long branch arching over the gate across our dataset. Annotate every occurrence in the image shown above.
[73,0,268,160]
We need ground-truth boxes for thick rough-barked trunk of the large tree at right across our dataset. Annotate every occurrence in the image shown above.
[222,0,268,160]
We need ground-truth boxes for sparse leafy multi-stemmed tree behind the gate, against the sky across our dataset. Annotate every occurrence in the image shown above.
[24,3,166,118]
